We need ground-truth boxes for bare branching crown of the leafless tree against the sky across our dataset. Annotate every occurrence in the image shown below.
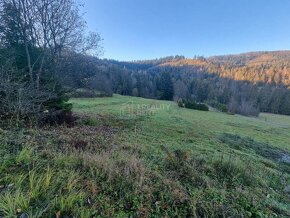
[1,0,101,89]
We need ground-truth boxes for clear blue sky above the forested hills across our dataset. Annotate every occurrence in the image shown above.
[82,0,290,60]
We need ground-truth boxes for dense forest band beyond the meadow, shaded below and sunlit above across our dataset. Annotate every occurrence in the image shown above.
[64,51,290,116]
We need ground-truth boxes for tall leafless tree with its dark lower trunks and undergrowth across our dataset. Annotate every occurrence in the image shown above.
[0,0,101,122]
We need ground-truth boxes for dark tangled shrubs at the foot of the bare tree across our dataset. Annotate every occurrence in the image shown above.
[0,70,72,126]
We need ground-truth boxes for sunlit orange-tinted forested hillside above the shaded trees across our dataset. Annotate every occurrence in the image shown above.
[148,51,290,86]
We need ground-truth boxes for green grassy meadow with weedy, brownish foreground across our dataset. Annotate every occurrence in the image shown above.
[0,95,290,217]
